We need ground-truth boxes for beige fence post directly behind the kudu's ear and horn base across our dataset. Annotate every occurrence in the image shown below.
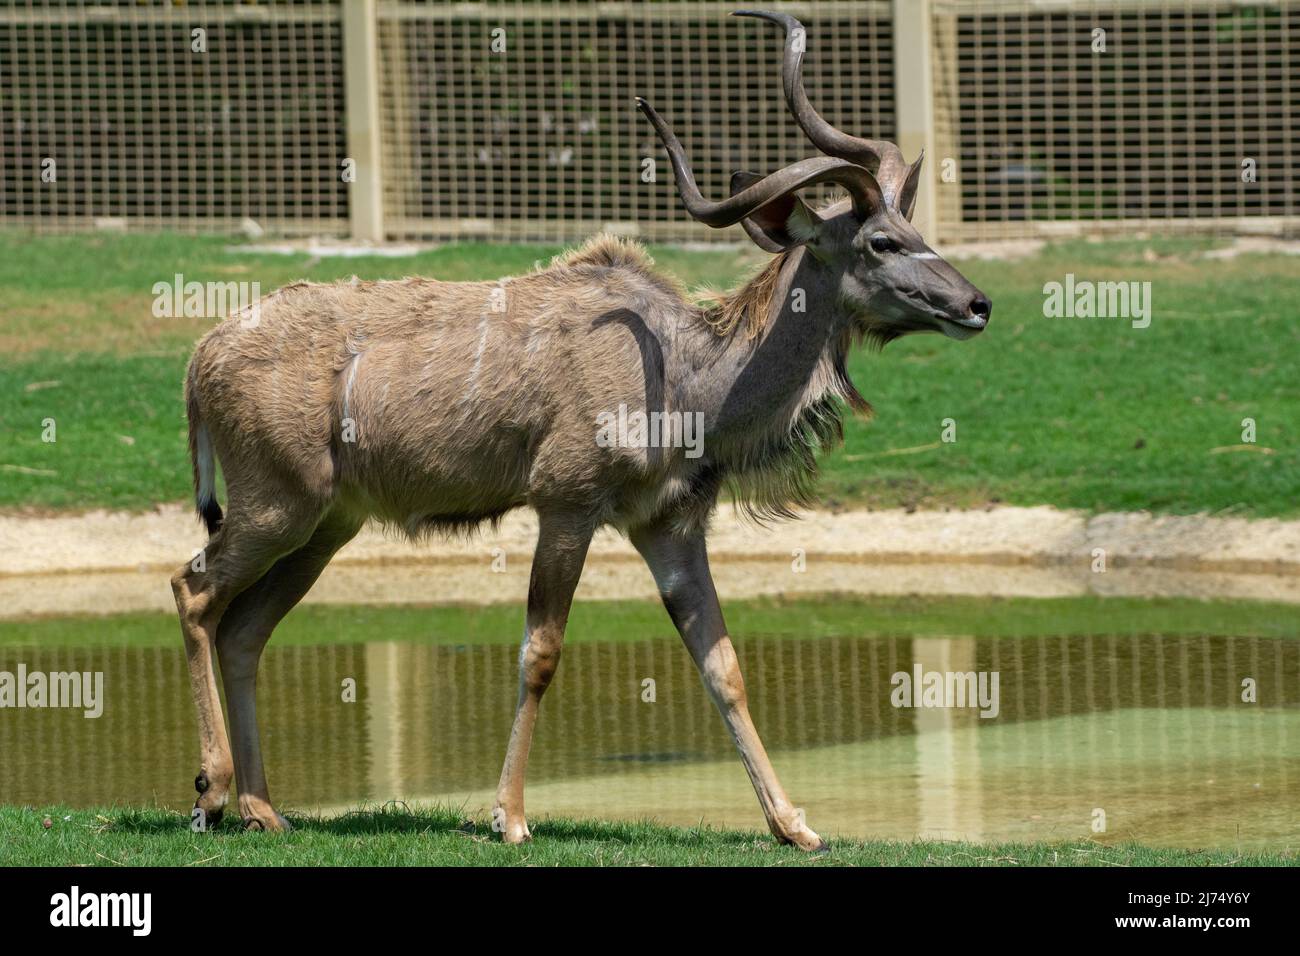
[893,0,939,242]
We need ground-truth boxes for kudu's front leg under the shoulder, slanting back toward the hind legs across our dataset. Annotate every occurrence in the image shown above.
[493,512,594,843]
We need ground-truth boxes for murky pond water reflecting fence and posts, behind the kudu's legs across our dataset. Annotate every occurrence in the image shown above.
[0,636,1300,849]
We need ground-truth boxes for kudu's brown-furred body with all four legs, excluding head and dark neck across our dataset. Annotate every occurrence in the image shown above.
[173,237,865,848]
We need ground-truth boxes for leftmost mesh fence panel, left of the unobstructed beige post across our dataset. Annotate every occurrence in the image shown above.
[0,0,348,233]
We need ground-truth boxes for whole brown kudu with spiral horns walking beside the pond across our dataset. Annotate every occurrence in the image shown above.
[172,13,989,849]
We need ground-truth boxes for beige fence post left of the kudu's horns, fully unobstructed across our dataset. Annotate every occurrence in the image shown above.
[343,0,385,242]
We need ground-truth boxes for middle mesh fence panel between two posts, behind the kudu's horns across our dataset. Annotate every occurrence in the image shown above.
[380,3,893,239]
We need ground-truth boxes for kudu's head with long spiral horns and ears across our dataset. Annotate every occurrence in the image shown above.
[637,10,992,342]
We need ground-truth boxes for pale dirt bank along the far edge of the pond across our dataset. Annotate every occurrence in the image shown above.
[0,506,1300,618]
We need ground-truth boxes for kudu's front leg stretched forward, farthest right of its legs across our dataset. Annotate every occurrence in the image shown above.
[632,528,826,851]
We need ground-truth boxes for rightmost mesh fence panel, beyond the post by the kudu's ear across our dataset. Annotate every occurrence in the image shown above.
[933,0,1300,239]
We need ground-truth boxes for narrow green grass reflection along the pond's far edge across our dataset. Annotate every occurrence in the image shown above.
[0,594,1300,648]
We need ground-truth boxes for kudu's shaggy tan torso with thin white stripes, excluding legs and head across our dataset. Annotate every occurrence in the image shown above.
[186,237,842,535]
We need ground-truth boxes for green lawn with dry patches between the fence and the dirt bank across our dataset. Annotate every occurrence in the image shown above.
[0,233,1300,516]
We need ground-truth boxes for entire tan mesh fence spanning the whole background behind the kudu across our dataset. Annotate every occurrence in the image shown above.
[0,0,1300,241]
